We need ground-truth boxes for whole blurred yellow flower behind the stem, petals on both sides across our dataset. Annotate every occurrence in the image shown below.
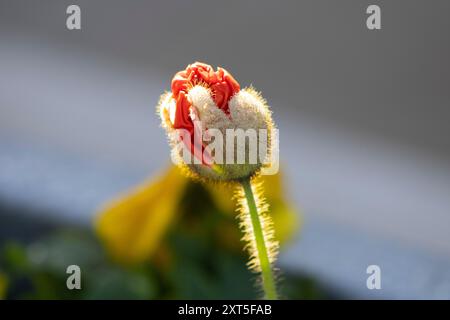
[95,166,299,263]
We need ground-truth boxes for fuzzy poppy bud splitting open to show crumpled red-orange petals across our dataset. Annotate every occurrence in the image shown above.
[157,62,274,181]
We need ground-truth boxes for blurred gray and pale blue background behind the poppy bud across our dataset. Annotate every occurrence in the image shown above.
[0,0,450,298]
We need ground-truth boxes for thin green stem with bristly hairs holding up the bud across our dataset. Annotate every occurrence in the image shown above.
[241,178,277,300]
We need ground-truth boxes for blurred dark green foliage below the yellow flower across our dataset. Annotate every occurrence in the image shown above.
[0,231,325,299]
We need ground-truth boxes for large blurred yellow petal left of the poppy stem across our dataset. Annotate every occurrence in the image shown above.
[95,166,187,263]
